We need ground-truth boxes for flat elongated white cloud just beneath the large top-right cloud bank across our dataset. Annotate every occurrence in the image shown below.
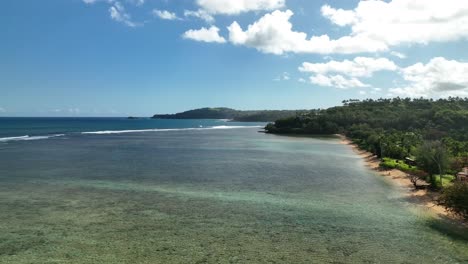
[299,57,398,77]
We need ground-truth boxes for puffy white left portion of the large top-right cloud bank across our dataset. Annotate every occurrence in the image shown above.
[228,10,386,55]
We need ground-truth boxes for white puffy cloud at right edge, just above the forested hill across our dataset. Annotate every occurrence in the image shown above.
[389,57,468,97]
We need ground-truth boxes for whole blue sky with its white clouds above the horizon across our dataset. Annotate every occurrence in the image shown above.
[0,0,468,116]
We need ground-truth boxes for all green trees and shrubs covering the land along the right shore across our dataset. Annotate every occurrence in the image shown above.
[265,97,468,219]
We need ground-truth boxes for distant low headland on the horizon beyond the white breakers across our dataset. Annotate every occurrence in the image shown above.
[152,107,307,122]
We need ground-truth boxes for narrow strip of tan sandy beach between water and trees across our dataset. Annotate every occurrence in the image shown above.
[337,135,468,227]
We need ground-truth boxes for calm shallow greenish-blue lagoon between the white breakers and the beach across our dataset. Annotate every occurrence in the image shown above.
[0,121,468,263]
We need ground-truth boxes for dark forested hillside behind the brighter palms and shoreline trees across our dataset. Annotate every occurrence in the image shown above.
[266,98,468,152]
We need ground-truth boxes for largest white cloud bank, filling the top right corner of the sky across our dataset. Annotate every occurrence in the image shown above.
[225,0,468,55]
